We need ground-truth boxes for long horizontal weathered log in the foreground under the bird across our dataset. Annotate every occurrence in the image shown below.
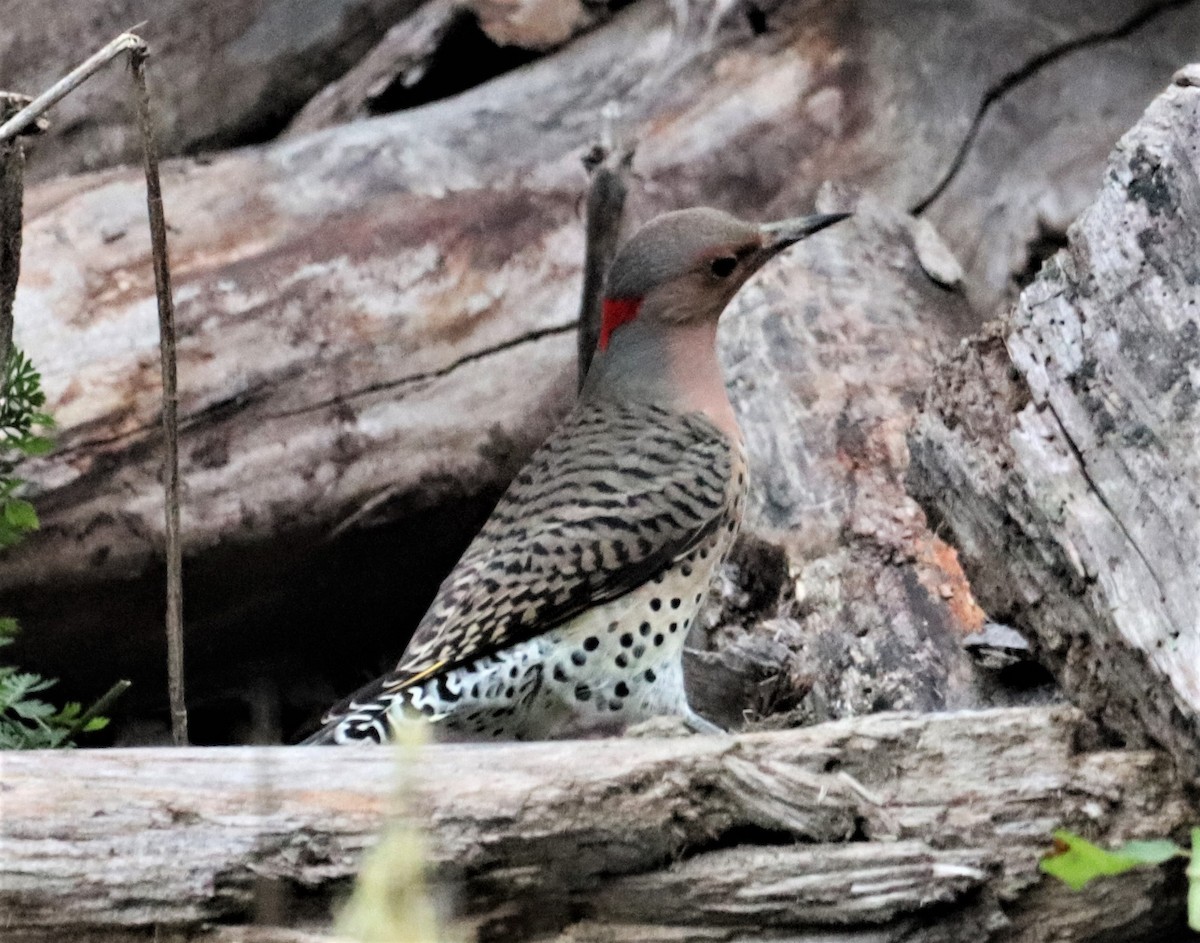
[0,708,1196,943]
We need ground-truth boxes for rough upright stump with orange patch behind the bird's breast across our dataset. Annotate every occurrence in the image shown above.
[689,187,1012,726]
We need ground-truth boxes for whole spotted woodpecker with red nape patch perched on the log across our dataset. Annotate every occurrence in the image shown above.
[305,209,847,744]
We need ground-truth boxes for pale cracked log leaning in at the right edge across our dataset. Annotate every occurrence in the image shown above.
[912,67,1200,776]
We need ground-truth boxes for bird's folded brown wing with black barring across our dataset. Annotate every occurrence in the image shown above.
[309,403,733,722]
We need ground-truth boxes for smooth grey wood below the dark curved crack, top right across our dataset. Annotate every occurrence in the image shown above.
[920,0,1200,314]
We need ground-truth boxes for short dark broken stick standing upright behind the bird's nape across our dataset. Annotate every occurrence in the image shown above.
[578,102,634,388]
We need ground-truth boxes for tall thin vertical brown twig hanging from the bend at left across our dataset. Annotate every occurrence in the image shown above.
[130,41,187,746]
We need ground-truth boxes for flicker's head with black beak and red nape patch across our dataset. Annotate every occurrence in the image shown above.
[599,206,850,352]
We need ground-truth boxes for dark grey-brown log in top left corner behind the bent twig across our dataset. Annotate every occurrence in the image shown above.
[0,0,420,179]
